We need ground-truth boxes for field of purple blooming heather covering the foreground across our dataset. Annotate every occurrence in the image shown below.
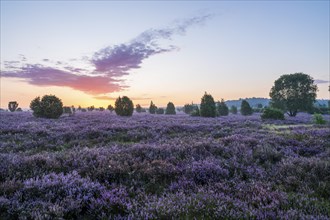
[0,111,330,219]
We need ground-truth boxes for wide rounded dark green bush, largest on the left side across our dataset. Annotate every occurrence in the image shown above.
[30,95,63,118]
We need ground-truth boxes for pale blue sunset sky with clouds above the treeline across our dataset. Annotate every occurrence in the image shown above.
[0,0,330,108]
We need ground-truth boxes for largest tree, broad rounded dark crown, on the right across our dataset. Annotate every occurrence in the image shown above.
[269,73,317,116]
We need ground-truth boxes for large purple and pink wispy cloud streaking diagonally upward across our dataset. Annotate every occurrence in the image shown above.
[1,14,212,94]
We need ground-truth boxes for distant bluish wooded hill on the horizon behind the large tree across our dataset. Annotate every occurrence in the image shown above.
[225,97,329,108]
